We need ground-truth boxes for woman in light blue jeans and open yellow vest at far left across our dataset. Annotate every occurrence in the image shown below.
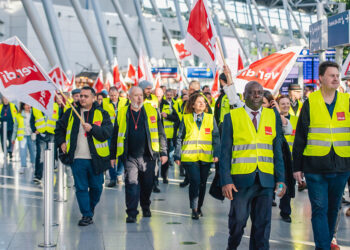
[16,103,36,174]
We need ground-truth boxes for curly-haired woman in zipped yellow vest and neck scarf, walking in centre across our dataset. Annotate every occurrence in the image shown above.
[174,93,220,220]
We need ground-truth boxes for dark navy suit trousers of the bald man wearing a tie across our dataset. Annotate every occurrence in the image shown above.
[227,176,273,250]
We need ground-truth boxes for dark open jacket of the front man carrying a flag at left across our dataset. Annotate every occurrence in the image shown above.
[55,102,113,174]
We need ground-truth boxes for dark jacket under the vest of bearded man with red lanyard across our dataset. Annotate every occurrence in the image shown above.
[111,106,168,162]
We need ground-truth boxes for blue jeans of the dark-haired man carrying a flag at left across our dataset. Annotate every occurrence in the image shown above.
[72,159,103,217]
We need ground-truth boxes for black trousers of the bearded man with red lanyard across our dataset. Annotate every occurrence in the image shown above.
[124,156,156,217]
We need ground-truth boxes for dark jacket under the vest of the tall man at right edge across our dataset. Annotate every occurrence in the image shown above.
[293,95,350,174]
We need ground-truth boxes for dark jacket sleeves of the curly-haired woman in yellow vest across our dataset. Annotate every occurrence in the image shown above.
[174,113,220,161]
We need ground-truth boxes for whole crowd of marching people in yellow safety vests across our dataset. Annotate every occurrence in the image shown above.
[0,62,350,249]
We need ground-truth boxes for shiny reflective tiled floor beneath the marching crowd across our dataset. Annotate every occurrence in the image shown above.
[0,159,350,250]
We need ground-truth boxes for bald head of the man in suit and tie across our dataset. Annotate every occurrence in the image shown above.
[244,81,264,110]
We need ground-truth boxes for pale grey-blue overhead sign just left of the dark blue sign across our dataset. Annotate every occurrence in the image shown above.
[309,20,328,52]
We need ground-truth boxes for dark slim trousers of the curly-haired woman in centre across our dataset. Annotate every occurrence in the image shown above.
[183,161,211,209]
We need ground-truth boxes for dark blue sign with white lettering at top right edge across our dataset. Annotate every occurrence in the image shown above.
[328,11,350,47]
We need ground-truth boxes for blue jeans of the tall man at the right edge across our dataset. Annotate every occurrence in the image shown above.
[305,172,350,250]
